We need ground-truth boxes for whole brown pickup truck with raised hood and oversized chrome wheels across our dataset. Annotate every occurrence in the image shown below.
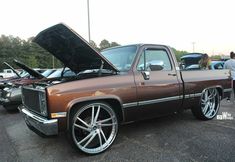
[19,24,232,154]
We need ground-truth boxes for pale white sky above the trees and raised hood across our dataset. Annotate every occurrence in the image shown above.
[0,0,235,55]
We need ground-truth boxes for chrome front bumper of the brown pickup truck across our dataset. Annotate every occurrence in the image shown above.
[19,106,58,136]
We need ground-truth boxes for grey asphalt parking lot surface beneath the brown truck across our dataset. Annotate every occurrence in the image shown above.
[0,101,235,162]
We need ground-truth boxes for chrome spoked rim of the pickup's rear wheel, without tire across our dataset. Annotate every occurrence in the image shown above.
[201,88,220,119]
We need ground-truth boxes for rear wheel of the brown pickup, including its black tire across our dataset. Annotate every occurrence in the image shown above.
[191,88,220,120]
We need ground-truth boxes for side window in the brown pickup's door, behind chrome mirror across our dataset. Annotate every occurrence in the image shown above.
[137,49,172,71]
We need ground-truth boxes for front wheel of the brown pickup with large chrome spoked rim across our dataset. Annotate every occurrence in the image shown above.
[72,103,118,154]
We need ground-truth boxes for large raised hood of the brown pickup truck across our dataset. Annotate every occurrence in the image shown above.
[33,23,118,73]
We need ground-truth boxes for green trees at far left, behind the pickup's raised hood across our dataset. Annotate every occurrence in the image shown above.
[0,35,62,69]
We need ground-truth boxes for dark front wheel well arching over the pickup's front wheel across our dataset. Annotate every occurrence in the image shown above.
[68,99,123,122]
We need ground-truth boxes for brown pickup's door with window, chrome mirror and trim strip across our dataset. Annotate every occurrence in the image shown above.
[133,46,182,118]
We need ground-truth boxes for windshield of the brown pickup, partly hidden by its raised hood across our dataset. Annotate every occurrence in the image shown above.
[101,45,137,71]
